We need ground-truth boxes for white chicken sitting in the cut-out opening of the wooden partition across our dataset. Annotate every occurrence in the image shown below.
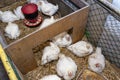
[53,32,72,47]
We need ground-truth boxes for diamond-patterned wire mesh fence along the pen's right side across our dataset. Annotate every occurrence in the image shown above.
[86,0,120,67]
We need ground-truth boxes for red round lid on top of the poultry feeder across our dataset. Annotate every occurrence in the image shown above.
[21,3,38,14]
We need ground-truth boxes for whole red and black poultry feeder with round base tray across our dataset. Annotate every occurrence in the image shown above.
[21,3,42,27]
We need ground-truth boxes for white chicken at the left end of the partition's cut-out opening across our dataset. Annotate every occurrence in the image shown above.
[41,42,60,65]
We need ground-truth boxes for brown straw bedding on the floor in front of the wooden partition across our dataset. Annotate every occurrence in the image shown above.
[25,38,120,80]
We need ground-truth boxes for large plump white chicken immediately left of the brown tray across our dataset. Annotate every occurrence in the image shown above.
[56,54,77,80]
